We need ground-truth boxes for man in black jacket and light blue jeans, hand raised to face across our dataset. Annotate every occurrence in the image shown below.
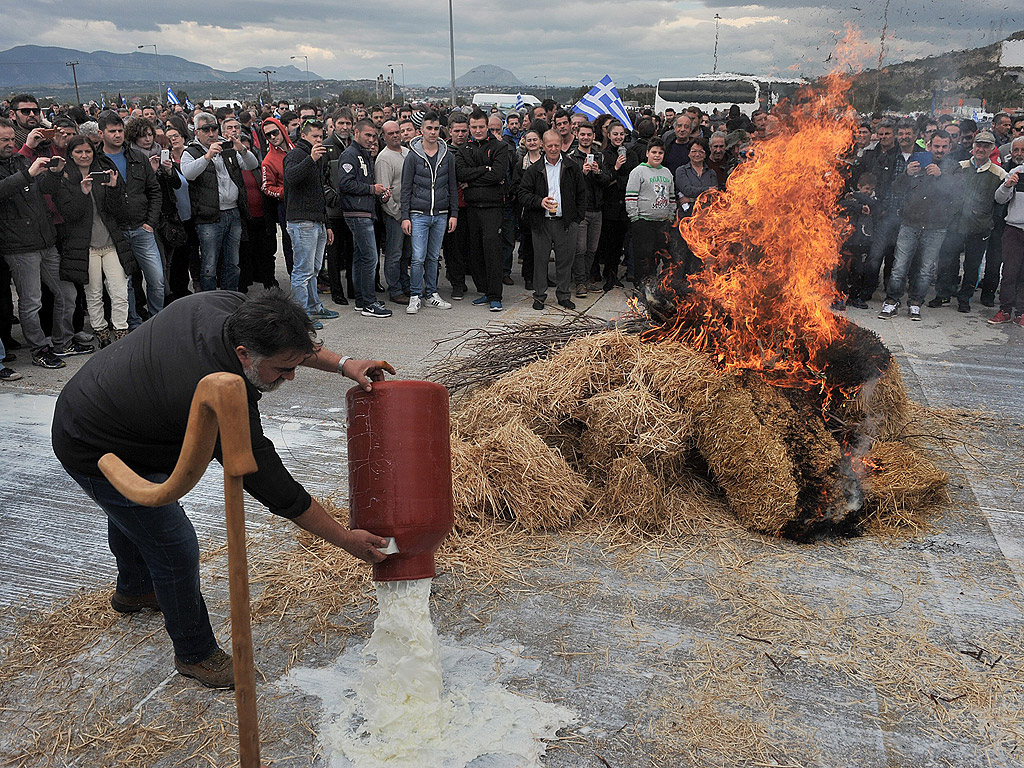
[284,120,338,331]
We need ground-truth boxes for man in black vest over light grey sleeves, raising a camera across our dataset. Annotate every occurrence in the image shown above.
[181,112,259,291]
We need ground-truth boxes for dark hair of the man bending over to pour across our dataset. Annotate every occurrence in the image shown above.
[224,288,319,357]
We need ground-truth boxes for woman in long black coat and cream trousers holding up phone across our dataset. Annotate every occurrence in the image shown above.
[57,136,138,347]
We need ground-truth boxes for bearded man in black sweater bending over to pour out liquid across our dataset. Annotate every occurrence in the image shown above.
[51,290,394,688]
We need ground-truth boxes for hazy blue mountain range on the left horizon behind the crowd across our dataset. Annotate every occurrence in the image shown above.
[0,45,324,87]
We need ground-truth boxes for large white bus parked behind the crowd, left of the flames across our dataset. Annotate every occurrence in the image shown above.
[654,73,807,115]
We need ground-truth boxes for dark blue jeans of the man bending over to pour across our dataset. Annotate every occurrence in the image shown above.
[65,467,217,664]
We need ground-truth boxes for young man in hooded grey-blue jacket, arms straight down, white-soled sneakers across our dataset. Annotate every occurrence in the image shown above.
[401,112,459,314]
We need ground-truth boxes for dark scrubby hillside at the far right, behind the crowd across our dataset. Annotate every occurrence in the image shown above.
[852,31,1024,112]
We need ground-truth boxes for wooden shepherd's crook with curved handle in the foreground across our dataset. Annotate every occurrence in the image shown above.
[99,373,260,768]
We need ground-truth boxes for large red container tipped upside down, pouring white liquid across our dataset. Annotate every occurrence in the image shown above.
[345,381,455,582]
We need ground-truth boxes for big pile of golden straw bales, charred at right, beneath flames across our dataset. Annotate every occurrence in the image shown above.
[444,331,945,541]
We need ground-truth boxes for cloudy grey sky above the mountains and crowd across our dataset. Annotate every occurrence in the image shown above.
[0,0,1024,87]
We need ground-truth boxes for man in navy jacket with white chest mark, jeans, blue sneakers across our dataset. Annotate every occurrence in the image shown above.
[338,120,391,317]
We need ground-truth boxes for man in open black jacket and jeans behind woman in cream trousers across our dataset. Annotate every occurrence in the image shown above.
[96,110,163,328]
